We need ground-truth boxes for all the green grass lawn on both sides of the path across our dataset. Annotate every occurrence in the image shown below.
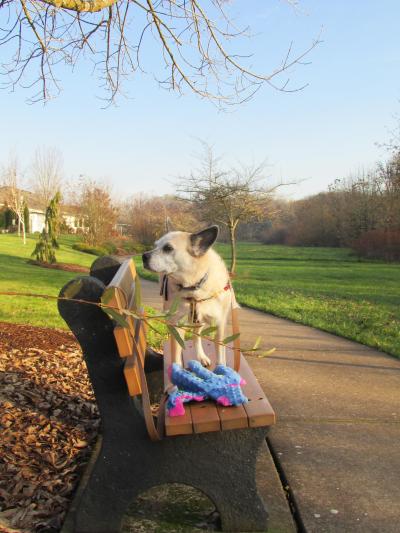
[0,235,400,357]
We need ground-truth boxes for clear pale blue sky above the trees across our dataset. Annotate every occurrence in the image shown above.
[0,0,400,202]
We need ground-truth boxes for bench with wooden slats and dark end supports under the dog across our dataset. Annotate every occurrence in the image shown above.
[59,257,275,533]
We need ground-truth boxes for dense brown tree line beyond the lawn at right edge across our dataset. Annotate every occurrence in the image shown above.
[260,148,400,260]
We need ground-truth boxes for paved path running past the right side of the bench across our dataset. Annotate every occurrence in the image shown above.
[143,282,400,533]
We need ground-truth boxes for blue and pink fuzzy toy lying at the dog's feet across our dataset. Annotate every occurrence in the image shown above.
[167,361,248,416]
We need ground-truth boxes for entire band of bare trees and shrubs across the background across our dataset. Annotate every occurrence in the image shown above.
[2,143,400,273]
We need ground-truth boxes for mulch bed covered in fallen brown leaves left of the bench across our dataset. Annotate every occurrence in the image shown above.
[0,323,99,533]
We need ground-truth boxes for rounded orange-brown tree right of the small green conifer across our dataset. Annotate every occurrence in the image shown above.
[78,179,117,245]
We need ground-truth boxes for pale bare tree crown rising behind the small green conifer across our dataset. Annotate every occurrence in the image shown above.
[31,146,63,207]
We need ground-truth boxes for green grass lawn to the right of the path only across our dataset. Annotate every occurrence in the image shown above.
[137,243,400,357]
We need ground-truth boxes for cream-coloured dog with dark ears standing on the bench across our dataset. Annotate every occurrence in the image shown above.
[142,226,236,366]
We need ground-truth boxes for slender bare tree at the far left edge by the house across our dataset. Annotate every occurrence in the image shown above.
[2,155,26,244]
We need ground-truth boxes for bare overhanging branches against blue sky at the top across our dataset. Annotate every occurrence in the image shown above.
[0,0,319,105]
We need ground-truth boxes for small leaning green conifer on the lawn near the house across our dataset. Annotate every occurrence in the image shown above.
[32,192,61,263]
